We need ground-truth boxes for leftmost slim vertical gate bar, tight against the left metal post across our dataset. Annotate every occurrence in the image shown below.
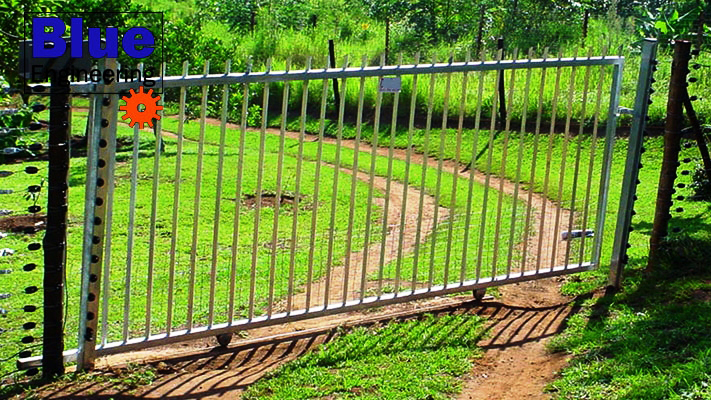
[101,94,119,346]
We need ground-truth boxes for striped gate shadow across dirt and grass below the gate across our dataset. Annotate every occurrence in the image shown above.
[8,296,589,400]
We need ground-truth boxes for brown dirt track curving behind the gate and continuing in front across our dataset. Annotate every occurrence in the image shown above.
[39,108,575,399]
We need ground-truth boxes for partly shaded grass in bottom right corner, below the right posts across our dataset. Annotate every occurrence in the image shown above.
[549,234,711,399]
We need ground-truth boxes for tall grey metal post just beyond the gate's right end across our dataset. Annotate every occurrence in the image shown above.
[608,39,657,288]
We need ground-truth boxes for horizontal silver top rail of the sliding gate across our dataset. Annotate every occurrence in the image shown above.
[44,56,624,93]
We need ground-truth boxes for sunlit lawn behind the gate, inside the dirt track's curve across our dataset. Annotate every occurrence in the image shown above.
[0,105,522,378]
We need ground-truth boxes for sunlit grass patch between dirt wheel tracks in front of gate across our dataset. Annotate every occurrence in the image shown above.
[244,315,484,399]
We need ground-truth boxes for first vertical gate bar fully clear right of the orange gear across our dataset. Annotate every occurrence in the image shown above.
[166,61,189,335]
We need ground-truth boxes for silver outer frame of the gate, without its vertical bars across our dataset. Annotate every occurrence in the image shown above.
[19,47,668,369]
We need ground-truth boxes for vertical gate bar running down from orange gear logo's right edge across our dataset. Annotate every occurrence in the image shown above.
[144,67,163,337]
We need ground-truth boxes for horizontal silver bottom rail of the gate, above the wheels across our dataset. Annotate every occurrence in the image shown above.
[17,262,595,370]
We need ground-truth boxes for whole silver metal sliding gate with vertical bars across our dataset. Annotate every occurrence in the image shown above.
[23,40,654,368]
